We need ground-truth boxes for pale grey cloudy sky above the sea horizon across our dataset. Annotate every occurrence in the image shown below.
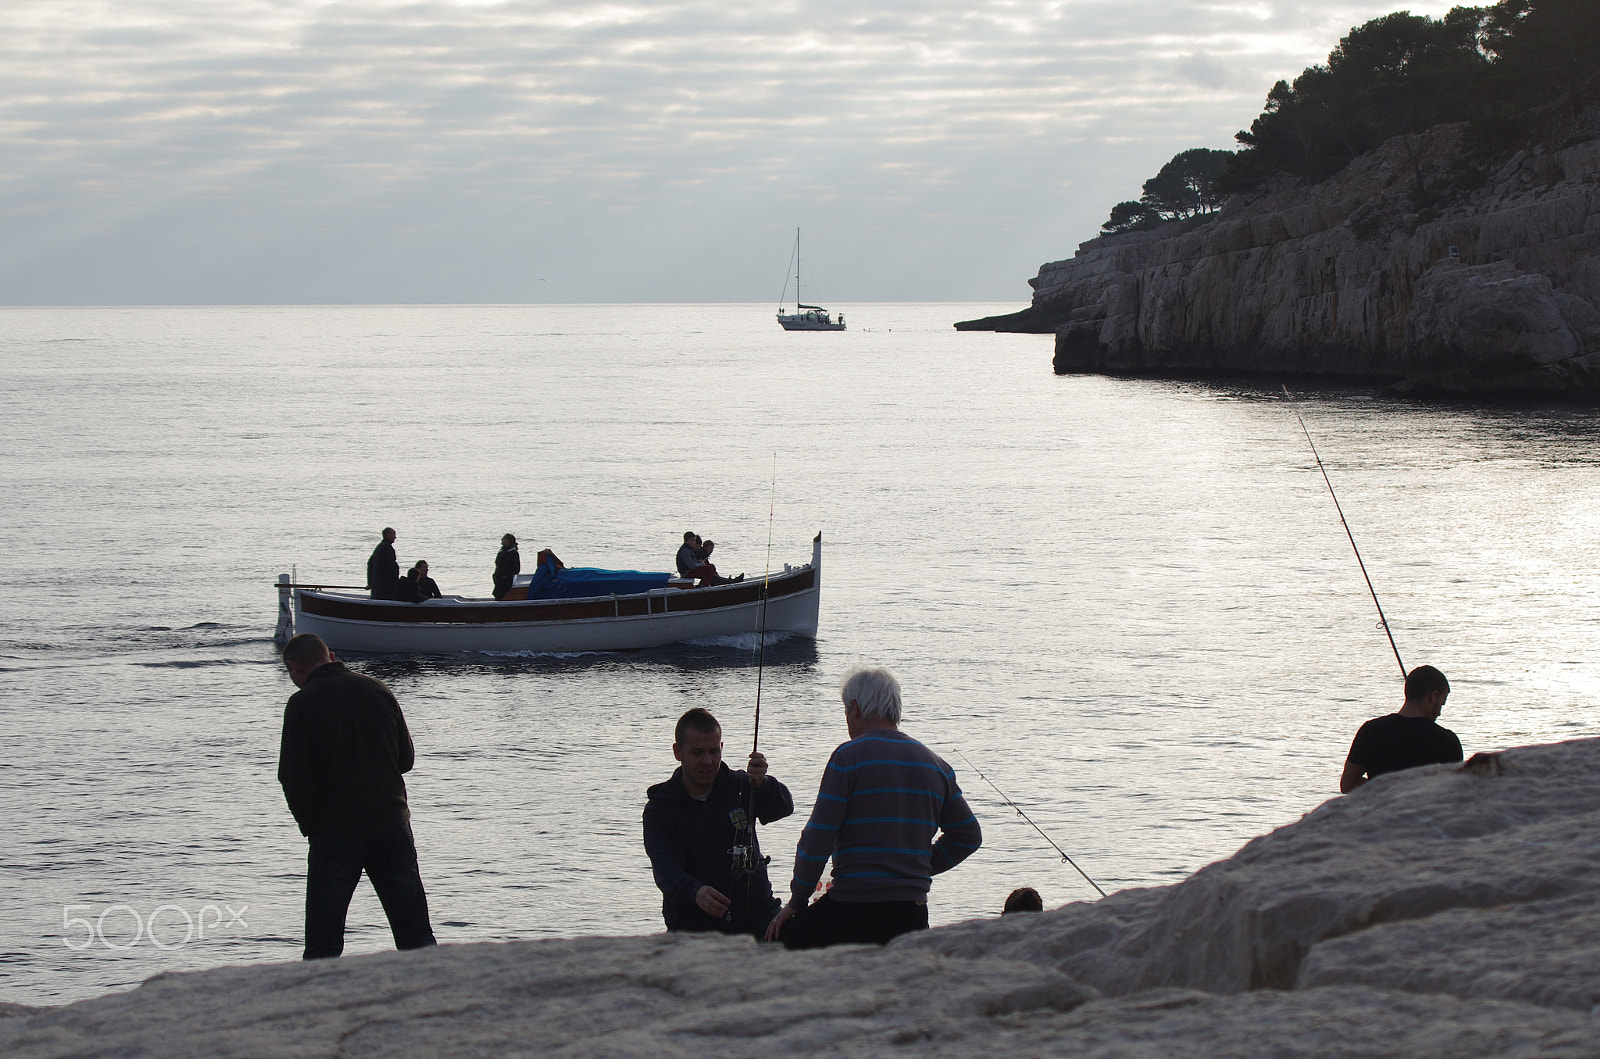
[0,0,1451,306]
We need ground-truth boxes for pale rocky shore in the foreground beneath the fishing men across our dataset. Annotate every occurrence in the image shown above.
[0,739,1600,1059]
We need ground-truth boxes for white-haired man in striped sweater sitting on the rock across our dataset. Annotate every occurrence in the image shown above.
[766,667,984,949]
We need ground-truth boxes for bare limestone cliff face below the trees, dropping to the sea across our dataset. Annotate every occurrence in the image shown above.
[957,110,1600,397]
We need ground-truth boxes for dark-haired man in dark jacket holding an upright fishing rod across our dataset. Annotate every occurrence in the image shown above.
[645,709,795,937]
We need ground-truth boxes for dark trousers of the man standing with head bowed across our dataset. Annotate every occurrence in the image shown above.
[304,827,437,960]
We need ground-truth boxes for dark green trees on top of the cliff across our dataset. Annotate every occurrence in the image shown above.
[1216,0,1600,192]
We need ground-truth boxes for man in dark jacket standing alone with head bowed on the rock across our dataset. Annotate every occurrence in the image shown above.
[278,633,435,960]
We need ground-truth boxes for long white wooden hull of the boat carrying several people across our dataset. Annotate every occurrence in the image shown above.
[278,533,822,654]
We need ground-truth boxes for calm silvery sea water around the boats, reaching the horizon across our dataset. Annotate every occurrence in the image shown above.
[0,304,1600,1003]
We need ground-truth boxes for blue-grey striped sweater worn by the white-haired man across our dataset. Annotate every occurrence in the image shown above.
[790,728,984,905]
